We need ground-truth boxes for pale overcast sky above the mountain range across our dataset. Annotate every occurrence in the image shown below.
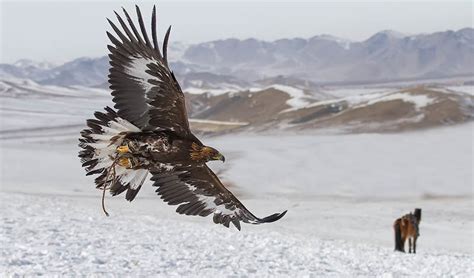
[0,0,473,63]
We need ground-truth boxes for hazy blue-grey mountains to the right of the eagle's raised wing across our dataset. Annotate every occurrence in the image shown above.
[184,28,474,83]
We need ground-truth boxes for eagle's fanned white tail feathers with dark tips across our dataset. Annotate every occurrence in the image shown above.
[79,107,148,201]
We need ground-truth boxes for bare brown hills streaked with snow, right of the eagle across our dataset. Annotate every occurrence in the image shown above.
[187,87,474,133]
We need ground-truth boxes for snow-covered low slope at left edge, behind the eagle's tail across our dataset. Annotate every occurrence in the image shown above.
[0,79,113,131]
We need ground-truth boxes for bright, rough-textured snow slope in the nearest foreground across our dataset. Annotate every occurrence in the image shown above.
[0,193,473,277]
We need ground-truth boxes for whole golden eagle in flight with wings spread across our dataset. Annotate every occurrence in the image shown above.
[79,6,286,230]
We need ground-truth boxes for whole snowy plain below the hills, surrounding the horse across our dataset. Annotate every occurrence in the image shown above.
[0,120,474,277]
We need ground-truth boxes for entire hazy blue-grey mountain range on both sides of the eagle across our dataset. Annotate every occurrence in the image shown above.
[0,28,474,89]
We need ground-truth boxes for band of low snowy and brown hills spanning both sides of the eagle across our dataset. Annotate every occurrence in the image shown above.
[0,79,474,138]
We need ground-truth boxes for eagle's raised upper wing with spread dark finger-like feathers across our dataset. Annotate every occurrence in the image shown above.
[107,6,191,137]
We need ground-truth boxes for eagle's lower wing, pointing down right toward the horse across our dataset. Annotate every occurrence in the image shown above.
[151,164,286,230]
